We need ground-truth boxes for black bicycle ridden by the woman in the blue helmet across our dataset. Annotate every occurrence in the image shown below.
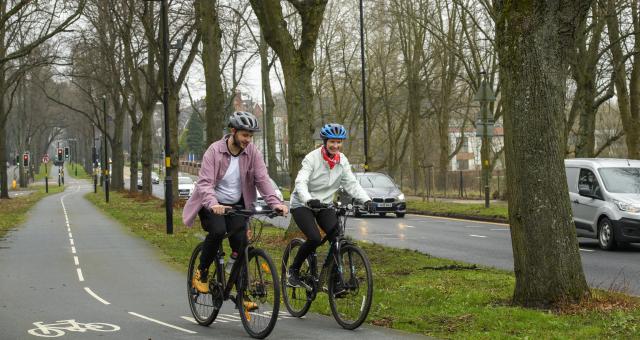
[281,202,373,330]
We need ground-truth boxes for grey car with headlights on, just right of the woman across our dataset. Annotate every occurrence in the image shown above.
[338,172,407,217]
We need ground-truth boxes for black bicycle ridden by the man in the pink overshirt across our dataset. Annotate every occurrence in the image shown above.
[187,208,280,339]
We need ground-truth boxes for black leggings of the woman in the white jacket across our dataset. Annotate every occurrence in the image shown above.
[291,207,338,270]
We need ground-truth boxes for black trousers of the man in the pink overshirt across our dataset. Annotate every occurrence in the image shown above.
[198,208,247,272]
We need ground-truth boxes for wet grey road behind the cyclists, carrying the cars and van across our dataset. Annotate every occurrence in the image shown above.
[121,171,640,295]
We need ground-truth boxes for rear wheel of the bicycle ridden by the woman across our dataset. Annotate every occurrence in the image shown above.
[280,238,315,318]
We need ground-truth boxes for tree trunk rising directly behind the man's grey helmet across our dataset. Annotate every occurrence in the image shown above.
[195,0,226,147]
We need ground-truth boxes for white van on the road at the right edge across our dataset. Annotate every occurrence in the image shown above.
[564,158,640,250]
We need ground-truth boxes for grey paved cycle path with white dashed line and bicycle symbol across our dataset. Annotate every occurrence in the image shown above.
[0,179,430,339]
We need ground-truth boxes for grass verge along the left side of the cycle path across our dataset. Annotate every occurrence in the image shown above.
[0,185,64,238]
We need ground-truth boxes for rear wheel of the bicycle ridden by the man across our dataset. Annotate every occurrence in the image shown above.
[187,243,222,326]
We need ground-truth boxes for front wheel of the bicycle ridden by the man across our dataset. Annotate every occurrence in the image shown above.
[237,249,280,339]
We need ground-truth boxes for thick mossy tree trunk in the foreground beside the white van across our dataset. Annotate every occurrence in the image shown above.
[494,0,590,308]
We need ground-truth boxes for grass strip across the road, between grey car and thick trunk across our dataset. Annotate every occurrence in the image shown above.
[407,200,509,223]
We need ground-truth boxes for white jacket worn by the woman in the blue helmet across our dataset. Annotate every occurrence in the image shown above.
[291,147,371,209]
